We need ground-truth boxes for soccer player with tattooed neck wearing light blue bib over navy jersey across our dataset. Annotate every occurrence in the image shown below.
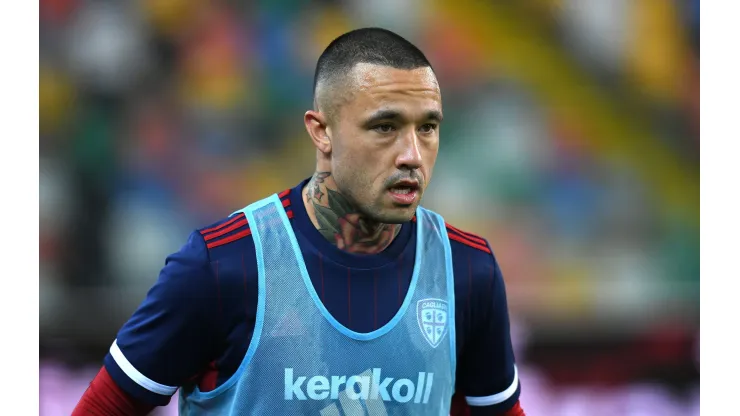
[74,28,524,416]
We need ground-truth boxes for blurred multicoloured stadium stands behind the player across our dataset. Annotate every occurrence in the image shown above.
[39,0,699,416]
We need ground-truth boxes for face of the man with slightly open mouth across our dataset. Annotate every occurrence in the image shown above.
[331,64,442,224]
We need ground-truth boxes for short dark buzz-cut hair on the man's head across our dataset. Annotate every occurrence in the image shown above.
[313,27,433,108]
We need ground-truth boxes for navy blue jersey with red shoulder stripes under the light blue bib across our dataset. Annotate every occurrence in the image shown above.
[105,179,520,414]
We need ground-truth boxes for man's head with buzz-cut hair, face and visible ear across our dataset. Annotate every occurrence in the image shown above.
[304,28,442,223]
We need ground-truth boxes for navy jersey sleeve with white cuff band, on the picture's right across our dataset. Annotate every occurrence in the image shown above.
[457,242,520,415]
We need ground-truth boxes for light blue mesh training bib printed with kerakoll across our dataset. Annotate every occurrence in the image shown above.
[180,195,456,416]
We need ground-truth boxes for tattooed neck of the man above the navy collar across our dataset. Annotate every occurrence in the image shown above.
[302,172,401,254]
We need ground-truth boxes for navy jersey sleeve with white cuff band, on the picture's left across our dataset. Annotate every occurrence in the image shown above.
[104,232,219,406]
